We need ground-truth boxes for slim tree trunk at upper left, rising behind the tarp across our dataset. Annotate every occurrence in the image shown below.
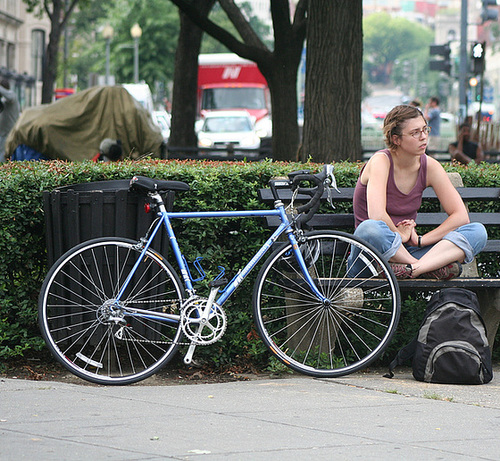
[23,0,82,104]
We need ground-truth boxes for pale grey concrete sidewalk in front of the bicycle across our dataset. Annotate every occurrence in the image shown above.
[0,369,500,461]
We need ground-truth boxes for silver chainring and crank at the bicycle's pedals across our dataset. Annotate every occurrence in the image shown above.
[181,298,227,346]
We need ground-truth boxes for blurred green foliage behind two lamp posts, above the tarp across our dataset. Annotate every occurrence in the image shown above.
[62,0,179,92]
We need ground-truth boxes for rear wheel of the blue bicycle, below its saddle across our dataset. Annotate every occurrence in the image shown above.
[38,238,183,384]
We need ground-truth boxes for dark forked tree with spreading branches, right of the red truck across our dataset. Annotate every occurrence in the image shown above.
[171,0,308,160]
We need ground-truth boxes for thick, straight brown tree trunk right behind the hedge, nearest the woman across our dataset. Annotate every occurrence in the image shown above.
[300,0,363,163]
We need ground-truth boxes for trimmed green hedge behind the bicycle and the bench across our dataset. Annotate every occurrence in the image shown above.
[0,160,500,368]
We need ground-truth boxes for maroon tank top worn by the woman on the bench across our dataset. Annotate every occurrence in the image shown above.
[353,149,427,227]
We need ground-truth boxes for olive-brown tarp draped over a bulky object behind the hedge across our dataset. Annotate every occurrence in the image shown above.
[6,86,163,161]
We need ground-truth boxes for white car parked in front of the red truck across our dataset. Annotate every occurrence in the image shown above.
[198,110,260,156]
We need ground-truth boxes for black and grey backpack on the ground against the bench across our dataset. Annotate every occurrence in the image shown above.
[384,288,493,384]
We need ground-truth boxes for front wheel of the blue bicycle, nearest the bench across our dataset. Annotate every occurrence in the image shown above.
[253,231,400,377]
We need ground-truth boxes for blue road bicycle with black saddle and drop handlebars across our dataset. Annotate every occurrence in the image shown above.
[39,165,400,384]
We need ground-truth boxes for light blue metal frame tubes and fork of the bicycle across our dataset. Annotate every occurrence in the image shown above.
[116,194,326,306]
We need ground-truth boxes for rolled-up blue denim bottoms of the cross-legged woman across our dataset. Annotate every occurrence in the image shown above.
[348,219,488,270]
